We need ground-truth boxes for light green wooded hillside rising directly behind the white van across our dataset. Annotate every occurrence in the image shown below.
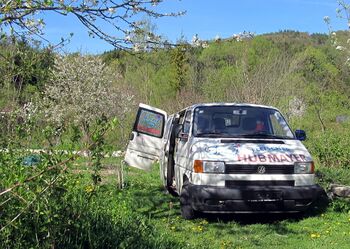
[102,31,350,164]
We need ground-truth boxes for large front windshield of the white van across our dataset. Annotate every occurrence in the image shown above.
[193,106,294,139]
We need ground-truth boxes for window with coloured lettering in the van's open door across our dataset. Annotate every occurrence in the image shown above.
[134,108,165,137]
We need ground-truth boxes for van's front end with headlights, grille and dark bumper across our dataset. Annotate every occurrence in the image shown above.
[187,160,324,213]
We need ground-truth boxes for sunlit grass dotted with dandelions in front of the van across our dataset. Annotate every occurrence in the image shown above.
[120,163,350,248]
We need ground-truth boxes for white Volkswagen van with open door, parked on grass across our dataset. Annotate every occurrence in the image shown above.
[125,103,323,219]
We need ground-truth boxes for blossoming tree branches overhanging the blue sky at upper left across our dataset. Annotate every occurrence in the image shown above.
[0,0,184,49]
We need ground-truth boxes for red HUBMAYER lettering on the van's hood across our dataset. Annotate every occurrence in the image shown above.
[237,154,307,163]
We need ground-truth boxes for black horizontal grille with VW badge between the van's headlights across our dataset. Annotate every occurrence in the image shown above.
[225,164,294,174]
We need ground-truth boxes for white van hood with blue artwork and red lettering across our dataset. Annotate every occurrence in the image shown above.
[191,138,312,164]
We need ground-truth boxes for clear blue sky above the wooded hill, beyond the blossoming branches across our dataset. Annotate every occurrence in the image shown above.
[44,0,347,53]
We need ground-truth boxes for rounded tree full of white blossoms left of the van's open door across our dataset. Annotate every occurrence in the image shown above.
[43,55,134,142]
